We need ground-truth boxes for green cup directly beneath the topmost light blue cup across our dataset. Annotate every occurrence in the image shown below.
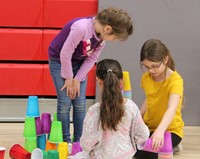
[23,117,36,137]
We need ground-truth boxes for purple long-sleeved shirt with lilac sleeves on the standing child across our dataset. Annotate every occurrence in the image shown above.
[49,17,105,81]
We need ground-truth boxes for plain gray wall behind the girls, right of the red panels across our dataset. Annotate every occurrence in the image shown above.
[97,0,200,125]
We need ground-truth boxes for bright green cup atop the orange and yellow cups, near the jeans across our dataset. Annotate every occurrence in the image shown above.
[49,121,63,143]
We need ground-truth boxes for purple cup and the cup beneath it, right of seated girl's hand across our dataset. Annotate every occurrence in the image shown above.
[158,132,173,159]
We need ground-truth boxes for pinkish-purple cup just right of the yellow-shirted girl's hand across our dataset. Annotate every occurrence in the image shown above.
[160,132,173,152]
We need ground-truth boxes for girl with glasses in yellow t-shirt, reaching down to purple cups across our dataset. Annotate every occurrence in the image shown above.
[134,39,184,159]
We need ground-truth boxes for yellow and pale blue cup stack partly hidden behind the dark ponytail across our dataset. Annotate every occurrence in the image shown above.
[122,71,132,99]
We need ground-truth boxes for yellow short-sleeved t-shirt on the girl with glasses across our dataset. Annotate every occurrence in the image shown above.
[141,71,184,138]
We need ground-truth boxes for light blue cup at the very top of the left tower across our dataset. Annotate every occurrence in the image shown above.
[26,96,40,117]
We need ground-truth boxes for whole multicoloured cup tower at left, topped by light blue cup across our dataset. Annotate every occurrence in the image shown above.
[23,96,68,159]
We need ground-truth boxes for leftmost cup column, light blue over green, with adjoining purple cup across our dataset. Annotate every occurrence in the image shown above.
[23,96,42,152]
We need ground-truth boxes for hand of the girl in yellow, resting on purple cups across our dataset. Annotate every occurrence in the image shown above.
[151,130,164,151]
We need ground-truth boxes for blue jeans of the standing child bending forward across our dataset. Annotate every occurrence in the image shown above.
[49,60,87,142]
